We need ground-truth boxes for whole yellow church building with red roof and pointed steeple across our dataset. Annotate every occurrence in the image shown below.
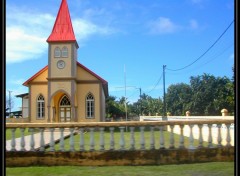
[23,0,108,123]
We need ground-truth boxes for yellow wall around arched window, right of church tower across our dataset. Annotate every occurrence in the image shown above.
[77,83,101,122]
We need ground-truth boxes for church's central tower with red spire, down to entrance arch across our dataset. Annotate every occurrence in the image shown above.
[47,0,78,122]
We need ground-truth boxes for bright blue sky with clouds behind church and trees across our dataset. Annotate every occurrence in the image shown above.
[6,0,234,110]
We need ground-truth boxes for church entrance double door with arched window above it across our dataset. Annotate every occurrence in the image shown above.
[59,95,71,122]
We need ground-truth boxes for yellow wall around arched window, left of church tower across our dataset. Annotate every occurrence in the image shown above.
[30,84,48,123]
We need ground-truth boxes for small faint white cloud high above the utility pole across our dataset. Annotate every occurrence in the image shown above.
[148,17,179,34]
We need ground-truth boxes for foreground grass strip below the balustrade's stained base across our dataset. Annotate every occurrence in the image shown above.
[6,162,234,176]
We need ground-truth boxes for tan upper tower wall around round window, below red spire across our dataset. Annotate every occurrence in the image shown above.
[51,43,72,77]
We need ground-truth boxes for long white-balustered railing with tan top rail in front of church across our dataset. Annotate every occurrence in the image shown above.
[6,119,234,152]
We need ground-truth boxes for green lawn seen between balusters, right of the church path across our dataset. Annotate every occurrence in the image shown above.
[47,126,211,150]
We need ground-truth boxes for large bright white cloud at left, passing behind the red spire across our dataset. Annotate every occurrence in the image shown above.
[6,6,116,64]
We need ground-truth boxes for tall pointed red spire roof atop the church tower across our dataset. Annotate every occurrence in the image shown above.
[47,0,76,42]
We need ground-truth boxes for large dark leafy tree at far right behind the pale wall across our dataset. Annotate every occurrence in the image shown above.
[190,73,234,115]
